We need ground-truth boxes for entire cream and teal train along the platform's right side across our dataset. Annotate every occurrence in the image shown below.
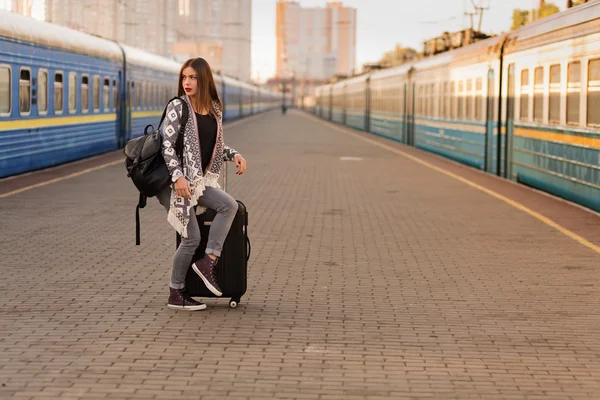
[314,1,600,211]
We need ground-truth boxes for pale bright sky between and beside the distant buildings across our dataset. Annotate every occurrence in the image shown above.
[252,0,566,81]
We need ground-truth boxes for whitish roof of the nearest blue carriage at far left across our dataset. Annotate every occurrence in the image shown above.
[0,10,123,60]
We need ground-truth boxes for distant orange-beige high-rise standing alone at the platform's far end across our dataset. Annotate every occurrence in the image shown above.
[276,0,356,80]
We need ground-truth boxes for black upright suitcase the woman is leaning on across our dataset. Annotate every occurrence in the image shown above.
[177,200,250,308]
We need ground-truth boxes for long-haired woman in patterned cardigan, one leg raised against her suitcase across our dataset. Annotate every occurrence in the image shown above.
[157,58,246,311]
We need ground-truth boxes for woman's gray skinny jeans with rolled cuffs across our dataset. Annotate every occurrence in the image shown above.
[156,186,238,289]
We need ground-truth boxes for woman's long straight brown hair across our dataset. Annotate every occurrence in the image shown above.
[177,57,223,115]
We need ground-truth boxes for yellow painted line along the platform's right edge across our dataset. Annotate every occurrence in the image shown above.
[313,117,600,254]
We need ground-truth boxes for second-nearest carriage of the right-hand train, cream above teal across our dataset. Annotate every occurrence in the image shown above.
[408,37,503,173]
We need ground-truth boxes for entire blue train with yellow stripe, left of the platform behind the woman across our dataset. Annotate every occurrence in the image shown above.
[0,11,281,178]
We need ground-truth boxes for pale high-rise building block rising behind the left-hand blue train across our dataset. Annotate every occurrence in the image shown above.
[38,0,252,80]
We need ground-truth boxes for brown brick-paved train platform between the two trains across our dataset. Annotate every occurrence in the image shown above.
[0,110,600,400]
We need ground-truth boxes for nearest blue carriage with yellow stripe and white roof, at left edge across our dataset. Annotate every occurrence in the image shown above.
[0,11,123,177]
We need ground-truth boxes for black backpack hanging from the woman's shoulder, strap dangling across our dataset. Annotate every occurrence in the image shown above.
[123,97,189,245]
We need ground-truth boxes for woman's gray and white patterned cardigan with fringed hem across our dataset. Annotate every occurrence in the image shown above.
[162,95,239,238]
